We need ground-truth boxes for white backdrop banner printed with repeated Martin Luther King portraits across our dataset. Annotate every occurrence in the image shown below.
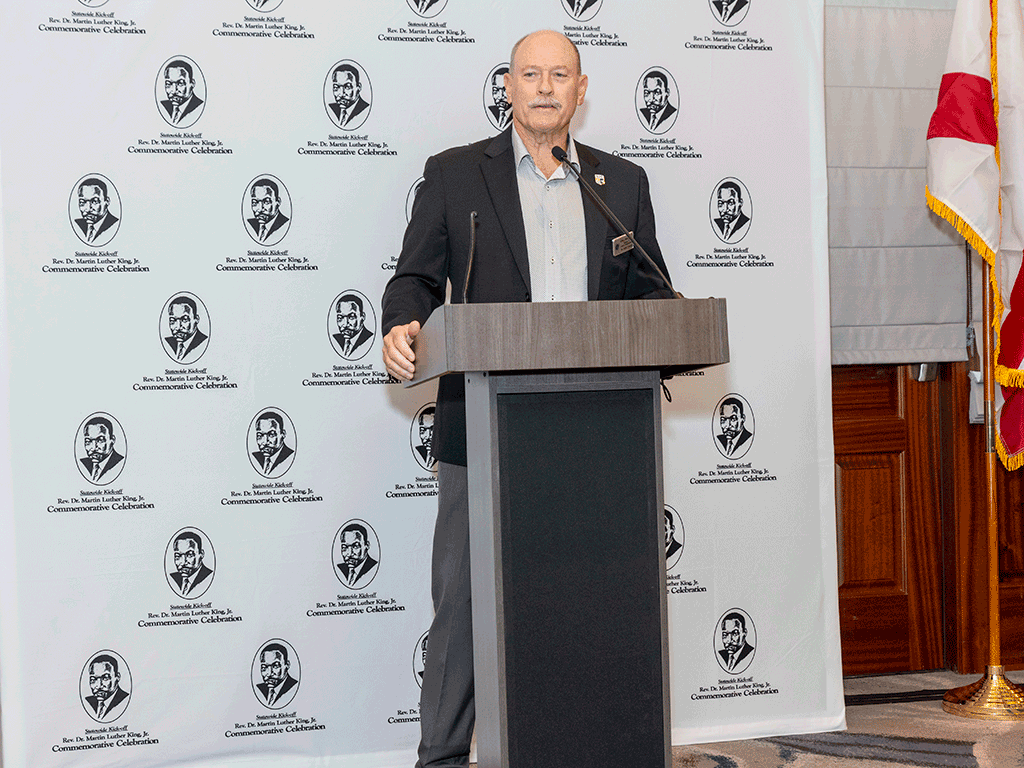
[0,0,844,768]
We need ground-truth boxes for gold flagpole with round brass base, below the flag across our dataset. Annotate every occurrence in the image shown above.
[942,260,1024,720]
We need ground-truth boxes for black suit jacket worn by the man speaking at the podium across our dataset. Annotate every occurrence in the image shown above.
[381,128,673,466]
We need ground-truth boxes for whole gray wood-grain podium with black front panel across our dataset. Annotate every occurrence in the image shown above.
[409,299,729,768]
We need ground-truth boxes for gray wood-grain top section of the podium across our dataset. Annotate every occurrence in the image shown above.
[406,299,729,386]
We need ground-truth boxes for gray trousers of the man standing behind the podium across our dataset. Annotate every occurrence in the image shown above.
[416,463,476,768]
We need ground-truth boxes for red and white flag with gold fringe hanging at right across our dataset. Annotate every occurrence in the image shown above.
[926,0,1024,469]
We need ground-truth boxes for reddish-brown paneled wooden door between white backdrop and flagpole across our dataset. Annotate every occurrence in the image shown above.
[833,366,943,675]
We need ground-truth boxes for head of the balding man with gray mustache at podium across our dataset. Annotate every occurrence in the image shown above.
[505,31,587,137]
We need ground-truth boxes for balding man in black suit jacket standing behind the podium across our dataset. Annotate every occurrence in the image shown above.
[381,31,673,768]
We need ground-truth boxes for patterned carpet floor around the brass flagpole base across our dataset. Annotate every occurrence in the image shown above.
[672,672,1024,768]
